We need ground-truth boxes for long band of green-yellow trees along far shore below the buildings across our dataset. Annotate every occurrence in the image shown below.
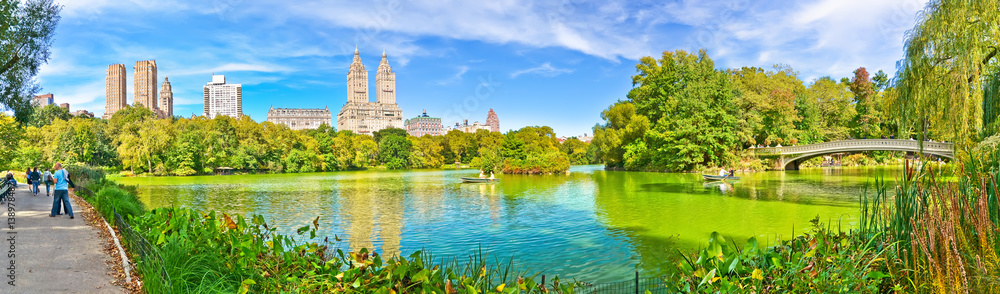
[0,106,596,176]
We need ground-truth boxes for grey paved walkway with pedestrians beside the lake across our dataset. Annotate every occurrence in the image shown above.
[0,184,123,293]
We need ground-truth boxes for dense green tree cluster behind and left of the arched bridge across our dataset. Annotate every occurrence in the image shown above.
[593,50,940,171]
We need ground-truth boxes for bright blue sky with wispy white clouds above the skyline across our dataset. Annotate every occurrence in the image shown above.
[38,0,925,136]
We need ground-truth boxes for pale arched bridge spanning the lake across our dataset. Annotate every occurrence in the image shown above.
[754,139,955,170]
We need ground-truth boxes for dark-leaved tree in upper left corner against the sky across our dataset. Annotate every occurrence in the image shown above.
[0,0,62,122]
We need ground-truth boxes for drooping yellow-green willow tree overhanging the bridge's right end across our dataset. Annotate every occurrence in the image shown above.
[896,0,1000,143]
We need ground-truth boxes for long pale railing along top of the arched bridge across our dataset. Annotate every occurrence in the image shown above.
[753,139,954,155]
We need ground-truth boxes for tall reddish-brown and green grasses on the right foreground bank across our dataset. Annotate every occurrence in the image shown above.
[858,150,1000,293]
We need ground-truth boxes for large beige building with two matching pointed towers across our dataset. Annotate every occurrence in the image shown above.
[337,49,403,135]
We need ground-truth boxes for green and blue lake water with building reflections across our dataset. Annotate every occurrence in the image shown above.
[114,166,898,283]
